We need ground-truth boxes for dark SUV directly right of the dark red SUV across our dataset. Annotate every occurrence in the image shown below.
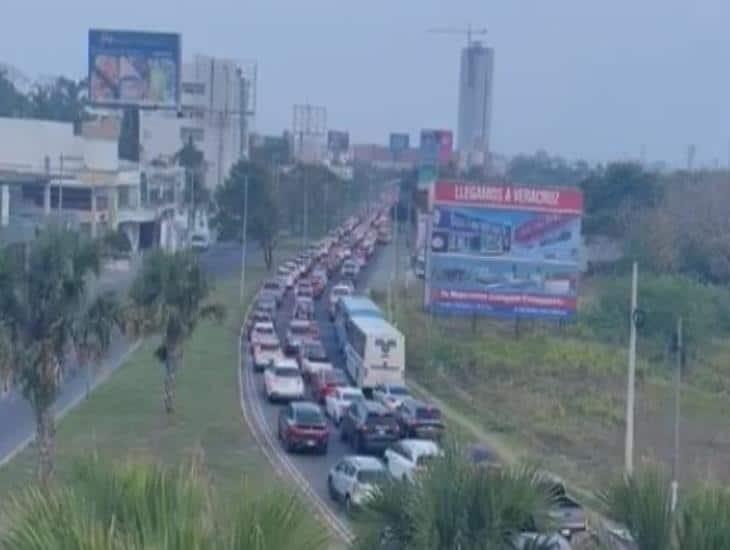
[340,400,400,453]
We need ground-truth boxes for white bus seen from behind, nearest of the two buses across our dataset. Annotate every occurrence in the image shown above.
[345,316,406,391]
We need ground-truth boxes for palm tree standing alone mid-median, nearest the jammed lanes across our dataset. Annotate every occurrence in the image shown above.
[130,251,225,414]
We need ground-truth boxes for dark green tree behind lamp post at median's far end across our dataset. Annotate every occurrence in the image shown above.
[213,161,279,269]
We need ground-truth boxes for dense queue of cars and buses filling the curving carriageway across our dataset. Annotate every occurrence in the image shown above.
[241,194,587,548]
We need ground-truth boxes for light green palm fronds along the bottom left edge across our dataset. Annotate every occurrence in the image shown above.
[0,459,328,550]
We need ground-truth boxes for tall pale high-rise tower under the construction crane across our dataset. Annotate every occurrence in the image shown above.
[457,42,494,167]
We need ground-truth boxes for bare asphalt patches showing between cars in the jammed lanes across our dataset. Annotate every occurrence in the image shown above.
[243,239,392,522]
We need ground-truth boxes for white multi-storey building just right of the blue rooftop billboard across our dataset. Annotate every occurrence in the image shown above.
[140,55,255,189]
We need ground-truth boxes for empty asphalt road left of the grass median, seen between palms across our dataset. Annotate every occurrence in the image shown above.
[0,243,263,466]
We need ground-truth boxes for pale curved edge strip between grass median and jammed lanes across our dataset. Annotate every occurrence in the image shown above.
[237,302,355,544]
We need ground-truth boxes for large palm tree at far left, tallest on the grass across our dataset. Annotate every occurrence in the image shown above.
[0,227,120,483]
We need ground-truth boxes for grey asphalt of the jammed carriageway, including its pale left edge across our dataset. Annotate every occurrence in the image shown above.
[241,238,392,540]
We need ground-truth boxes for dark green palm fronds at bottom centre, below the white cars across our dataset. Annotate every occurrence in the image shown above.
[358,447,551,550]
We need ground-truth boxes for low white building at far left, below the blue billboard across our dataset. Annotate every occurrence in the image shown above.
[0,118,187,251]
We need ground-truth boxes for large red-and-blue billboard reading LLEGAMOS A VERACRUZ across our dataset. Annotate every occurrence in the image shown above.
[425,181,583,319]
